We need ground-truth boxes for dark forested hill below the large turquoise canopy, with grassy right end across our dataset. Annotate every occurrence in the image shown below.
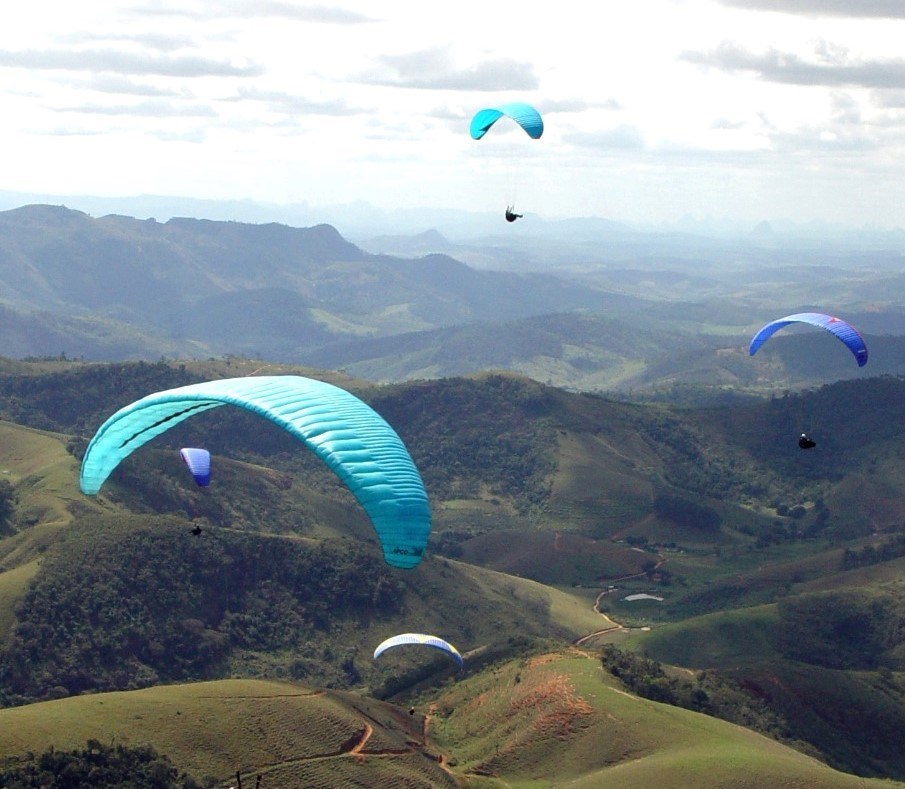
[0,515,616,703]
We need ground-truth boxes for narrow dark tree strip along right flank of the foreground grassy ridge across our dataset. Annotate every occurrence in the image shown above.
[601,644,789,740]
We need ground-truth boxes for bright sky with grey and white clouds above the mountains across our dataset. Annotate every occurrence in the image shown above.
[0,0,905,226]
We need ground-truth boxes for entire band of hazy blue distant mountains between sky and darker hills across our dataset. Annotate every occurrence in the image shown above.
[0,200,905,390]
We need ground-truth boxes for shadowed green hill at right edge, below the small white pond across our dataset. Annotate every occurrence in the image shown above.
[633,559,905,778]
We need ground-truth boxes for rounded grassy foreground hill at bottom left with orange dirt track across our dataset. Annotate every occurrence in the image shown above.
[0,680,455,787]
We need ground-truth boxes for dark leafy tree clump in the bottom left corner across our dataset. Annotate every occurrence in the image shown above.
[0,740,205,789]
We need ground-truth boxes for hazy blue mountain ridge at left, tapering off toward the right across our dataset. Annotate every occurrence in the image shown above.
[0,206,625,361]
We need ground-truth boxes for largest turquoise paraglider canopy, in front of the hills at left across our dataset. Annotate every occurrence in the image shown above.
[79,375,430,568]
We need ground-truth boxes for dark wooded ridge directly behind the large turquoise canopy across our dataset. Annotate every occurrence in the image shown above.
[0,362,556,509]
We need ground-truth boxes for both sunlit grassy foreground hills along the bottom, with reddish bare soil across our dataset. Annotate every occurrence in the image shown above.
[0,651,895,787]
